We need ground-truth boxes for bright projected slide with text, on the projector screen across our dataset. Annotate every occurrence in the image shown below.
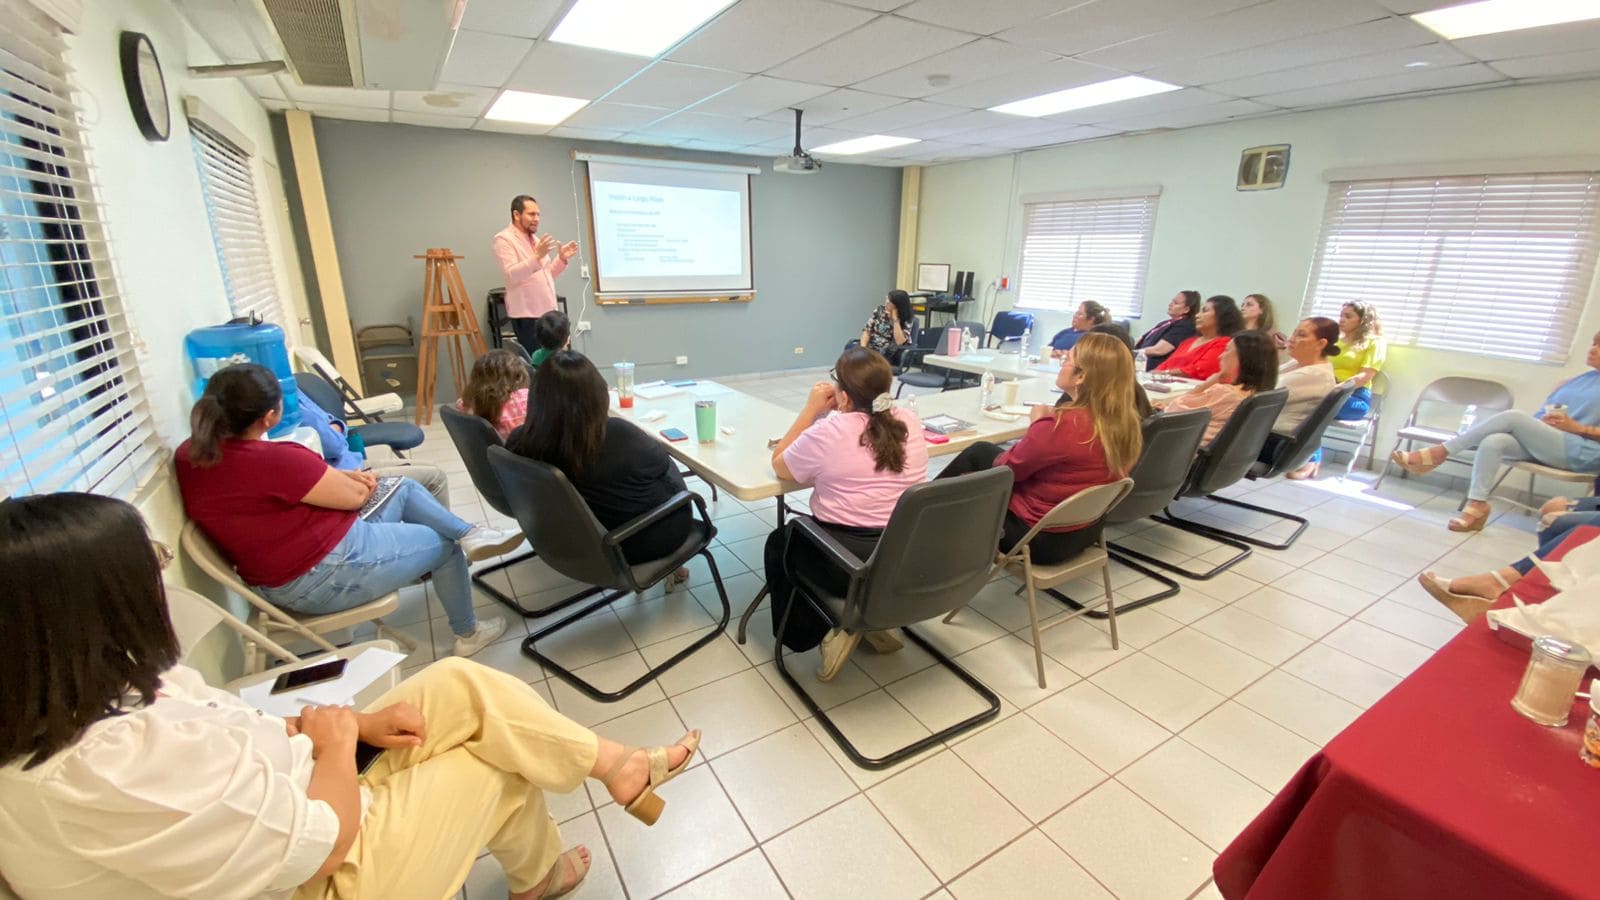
[594,181,744,279]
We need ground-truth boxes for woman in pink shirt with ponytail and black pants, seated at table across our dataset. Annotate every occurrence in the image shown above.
[766,348,928,681]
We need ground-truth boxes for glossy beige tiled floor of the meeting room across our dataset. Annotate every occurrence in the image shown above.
[371,372,1533,900]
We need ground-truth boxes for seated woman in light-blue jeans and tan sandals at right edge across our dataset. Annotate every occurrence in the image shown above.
[1390,335,1600,532]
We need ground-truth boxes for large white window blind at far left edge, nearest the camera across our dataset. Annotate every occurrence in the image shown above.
[0,0,162,496]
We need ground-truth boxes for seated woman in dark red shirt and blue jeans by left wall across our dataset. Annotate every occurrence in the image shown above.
[174,365,522,657]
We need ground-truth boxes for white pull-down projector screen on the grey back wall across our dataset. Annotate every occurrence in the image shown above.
[579,157,754,294]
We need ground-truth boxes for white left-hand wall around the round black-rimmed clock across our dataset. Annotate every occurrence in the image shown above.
[67,0,299,674]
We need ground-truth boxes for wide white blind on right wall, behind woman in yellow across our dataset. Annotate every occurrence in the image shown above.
[1306,171,1600,365]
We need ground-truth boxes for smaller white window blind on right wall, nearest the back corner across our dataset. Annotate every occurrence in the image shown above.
[1018,194,1158,317]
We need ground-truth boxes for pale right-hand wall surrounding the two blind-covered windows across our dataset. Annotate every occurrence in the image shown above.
[918,80,1600,452]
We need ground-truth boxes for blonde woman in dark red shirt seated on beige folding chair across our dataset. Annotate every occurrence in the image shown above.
[939,331,1144,565]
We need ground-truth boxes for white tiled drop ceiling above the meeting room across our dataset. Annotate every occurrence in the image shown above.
[181,0,1600,167]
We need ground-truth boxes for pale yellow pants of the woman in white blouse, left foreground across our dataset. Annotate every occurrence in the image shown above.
[294,658,598,900]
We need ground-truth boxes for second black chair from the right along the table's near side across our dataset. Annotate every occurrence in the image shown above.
[1120,388,1290,576]
